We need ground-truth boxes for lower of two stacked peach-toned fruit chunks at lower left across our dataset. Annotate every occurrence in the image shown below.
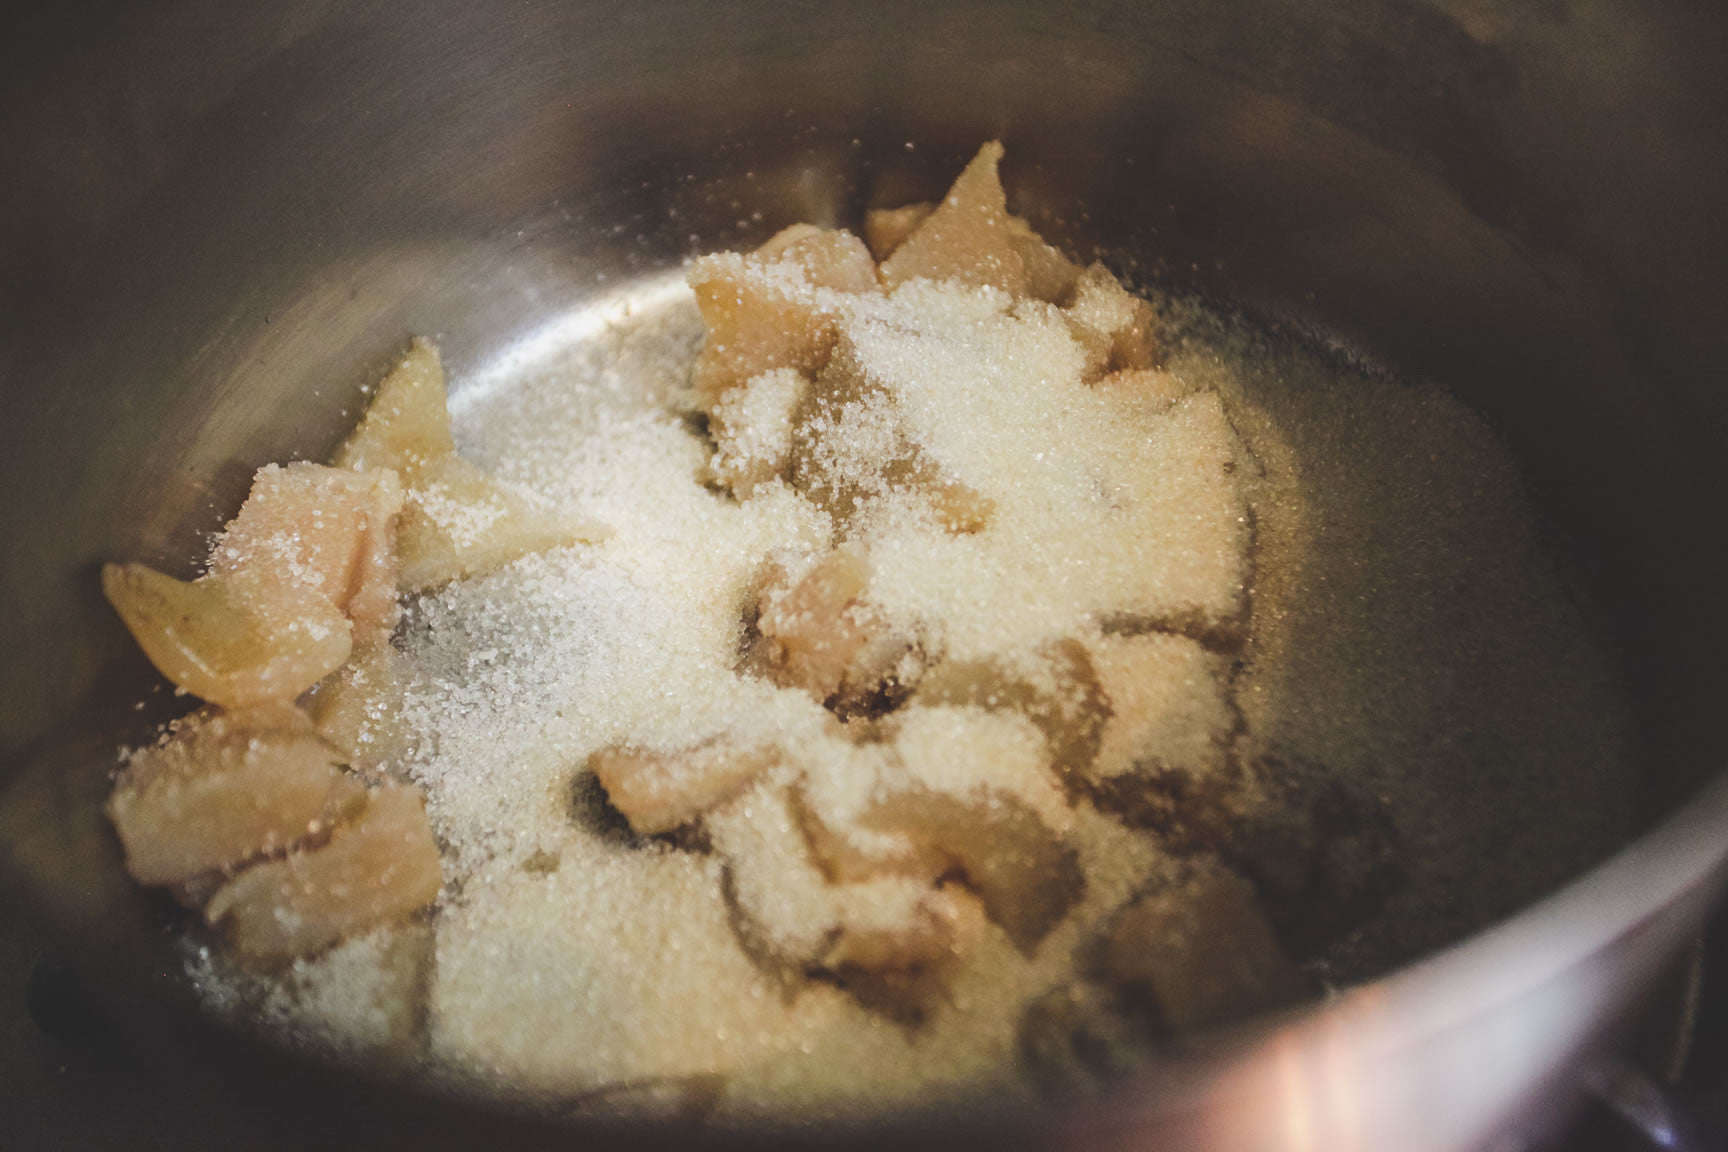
[204,784,444,960]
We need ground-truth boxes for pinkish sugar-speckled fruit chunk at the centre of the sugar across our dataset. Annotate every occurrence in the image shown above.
[757,546,912,701]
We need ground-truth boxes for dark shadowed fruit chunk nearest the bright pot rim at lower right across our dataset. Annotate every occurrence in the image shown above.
[1104,865,1308,1035]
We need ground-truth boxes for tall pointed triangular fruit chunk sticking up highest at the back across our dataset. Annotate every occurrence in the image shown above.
[881,140,1026,295]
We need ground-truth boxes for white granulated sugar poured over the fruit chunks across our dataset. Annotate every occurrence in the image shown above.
[189,267,1630,1123]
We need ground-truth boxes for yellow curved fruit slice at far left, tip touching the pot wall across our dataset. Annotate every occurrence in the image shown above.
[102,565,353,708]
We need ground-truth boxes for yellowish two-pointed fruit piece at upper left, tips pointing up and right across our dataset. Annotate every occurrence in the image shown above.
[337,340,607,592]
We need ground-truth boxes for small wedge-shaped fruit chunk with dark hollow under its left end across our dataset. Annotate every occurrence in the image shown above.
[588,736,779,836]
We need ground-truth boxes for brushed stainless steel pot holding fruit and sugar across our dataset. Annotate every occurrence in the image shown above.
[0,0,1728,1150]
